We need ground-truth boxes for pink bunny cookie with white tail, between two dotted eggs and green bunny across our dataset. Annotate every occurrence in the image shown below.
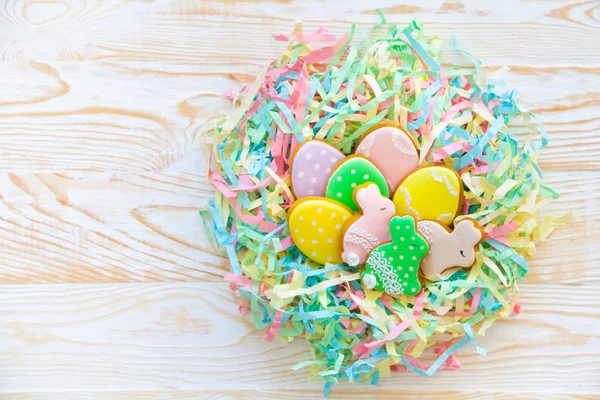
[342,183,396,267]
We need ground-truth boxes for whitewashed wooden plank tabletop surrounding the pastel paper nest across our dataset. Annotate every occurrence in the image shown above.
[0,0,600,400]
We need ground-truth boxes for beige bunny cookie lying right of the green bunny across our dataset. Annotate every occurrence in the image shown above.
[417,219,483,281]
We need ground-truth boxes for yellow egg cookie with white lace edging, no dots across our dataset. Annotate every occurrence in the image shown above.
[393,165,463,226]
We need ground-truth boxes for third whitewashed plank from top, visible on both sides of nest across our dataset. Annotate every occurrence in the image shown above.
[0,170,600,284]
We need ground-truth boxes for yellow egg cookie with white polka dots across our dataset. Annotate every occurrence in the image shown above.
[288,197,352,264]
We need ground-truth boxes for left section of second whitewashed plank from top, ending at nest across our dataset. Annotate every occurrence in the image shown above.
[0,62,229,172]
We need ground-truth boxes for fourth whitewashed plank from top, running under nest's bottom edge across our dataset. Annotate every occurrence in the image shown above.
[0,283,600,398]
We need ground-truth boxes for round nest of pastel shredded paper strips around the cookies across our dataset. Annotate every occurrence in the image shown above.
[201,17,568,392]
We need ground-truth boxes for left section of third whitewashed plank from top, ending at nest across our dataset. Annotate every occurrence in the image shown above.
[0,172,225,283]
